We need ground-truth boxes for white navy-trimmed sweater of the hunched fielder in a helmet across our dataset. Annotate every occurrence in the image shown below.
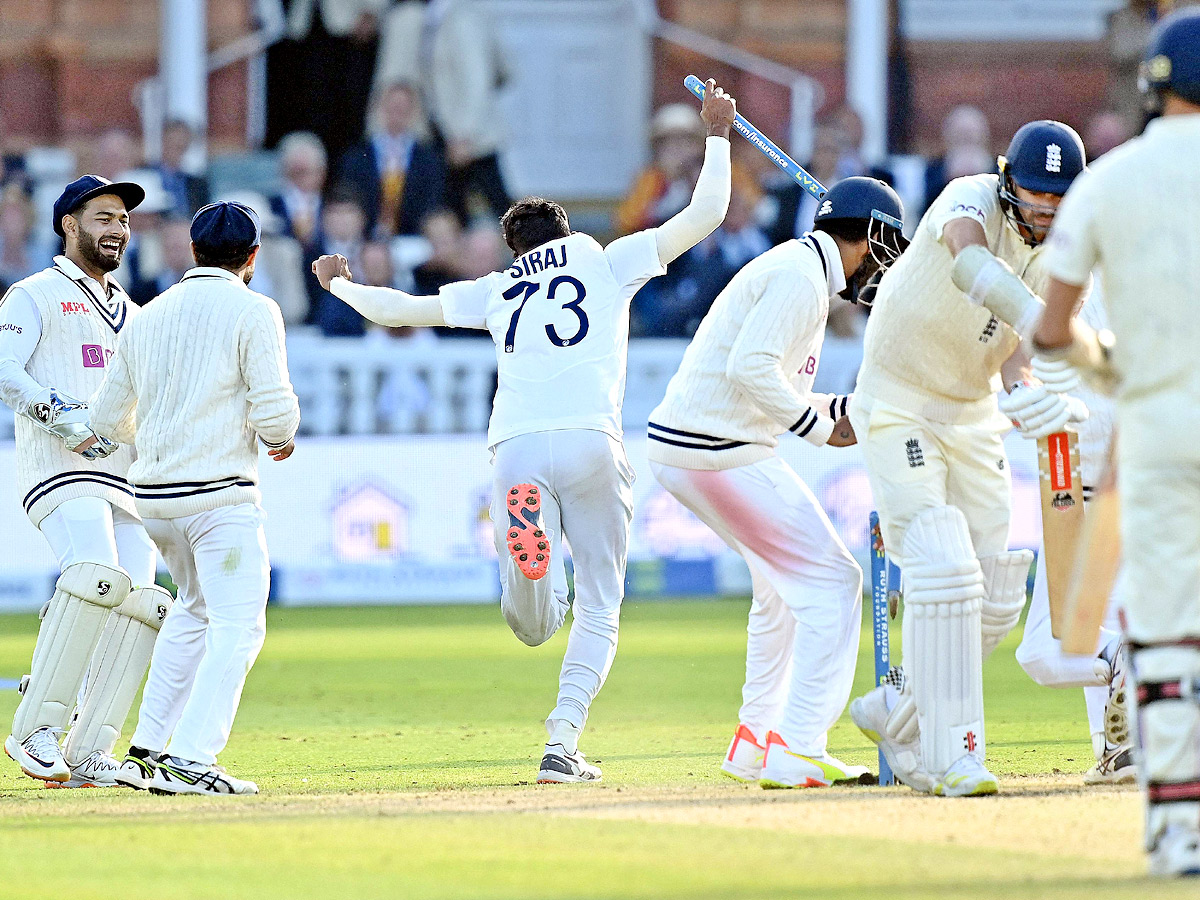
[647,232,846,469]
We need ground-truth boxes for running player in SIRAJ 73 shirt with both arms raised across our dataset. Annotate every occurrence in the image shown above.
[313,80,736,782]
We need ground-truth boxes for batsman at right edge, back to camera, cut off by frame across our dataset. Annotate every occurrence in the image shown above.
[984,10,1200,877]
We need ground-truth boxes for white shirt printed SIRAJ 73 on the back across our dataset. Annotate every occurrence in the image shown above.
[440,229,666,446]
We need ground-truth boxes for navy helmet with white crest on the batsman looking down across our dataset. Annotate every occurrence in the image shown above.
[997,119,1087,246]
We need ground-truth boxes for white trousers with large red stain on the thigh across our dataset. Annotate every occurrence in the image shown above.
[650,456,863,756]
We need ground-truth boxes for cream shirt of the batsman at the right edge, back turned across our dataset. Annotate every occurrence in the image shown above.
[1046,114,1200,456]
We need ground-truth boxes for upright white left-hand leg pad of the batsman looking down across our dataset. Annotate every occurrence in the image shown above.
[904,506,985,778]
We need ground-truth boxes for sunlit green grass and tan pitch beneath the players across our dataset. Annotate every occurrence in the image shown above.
[0,601,1180,900]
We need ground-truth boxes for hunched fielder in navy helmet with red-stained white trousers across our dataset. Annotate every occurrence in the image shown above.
[648,178,905,787]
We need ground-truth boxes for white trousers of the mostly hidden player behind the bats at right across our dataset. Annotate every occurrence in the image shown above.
[1016,535,1121,734]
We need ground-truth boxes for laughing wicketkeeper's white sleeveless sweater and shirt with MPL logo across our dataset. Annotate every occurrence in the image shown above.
[0,256,138,526]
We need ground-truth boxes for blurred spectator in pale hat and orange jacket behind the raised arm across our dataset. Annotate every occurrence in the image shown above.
[614,103,704,234]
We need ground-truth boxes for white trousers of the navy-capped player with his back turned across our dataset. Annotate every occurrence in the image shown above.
[132,503,271,764]
